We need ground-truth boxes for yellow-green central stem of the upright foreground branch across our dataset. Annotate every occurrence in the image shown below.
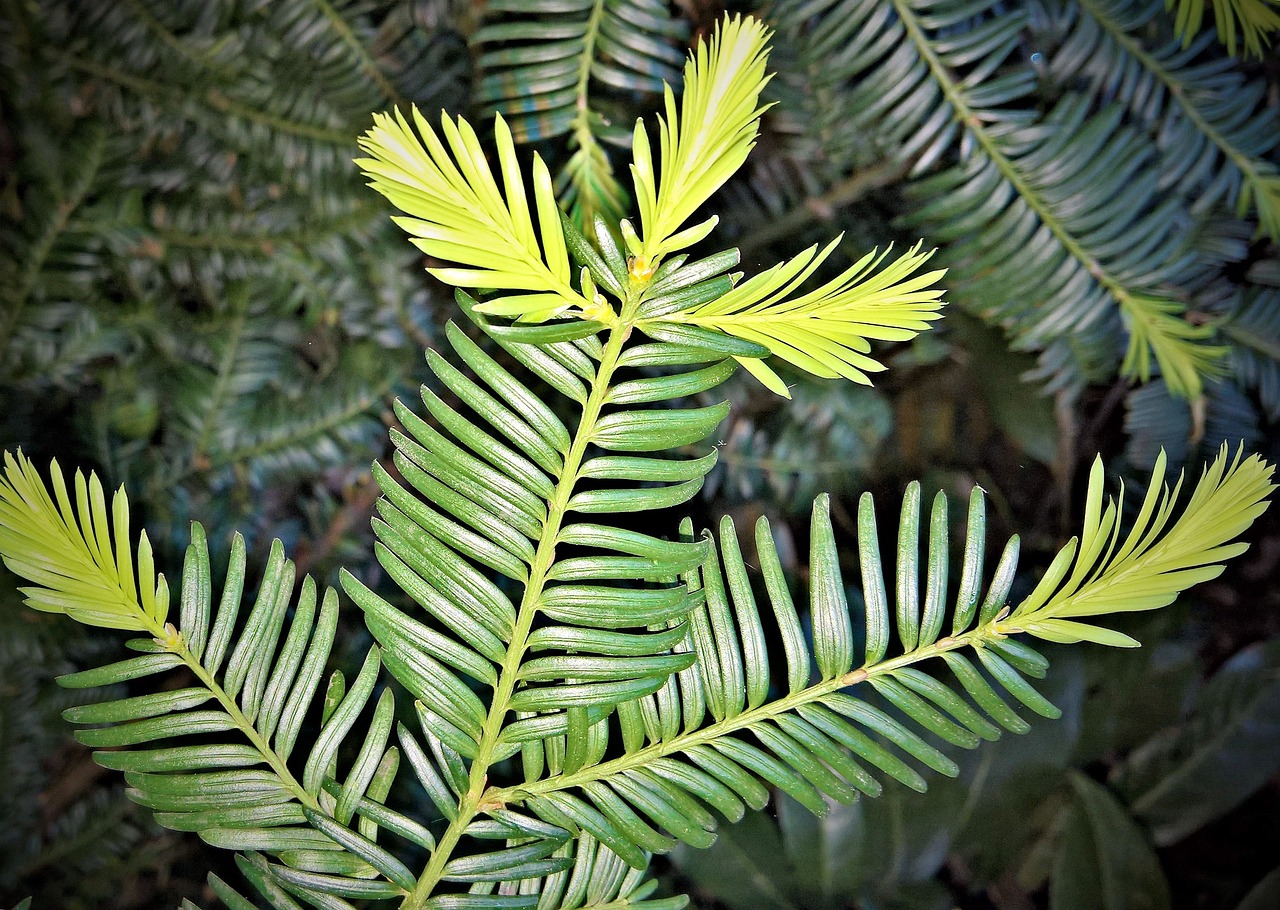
[402,287,643,910]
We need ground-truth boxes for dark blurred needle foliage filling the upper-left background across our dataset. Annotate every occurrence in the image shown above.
[0,0,465,563]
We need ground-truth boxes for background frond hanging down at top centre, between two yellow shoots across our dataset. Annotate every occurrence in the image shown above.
[471,0,687,234]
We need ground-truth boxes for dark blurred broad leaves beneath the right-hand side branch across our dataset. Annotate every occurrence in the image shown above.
[676,614,1280,910]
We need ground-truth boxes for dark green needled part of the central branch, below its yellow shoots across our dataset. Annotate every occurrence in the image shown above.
[344,282,733,759]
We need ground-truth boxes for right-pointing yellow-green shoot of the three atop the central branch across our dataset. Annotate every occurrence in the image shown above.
[641,237,945,397]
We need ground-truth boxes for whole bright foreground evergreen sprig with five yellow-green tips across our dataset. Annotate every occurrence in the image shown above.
[0,6,1274,910]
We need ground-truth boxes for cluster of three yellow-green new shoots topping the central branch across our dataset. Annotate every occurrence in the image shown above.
[358,10,943,395]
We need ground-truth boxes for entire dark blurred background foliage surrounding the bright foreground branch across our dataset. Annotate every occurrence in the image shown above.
[0,0,1280,910]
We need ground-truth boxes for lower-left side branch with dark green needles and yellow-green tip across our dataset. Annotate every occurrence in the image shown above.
[0,453,422,900]
